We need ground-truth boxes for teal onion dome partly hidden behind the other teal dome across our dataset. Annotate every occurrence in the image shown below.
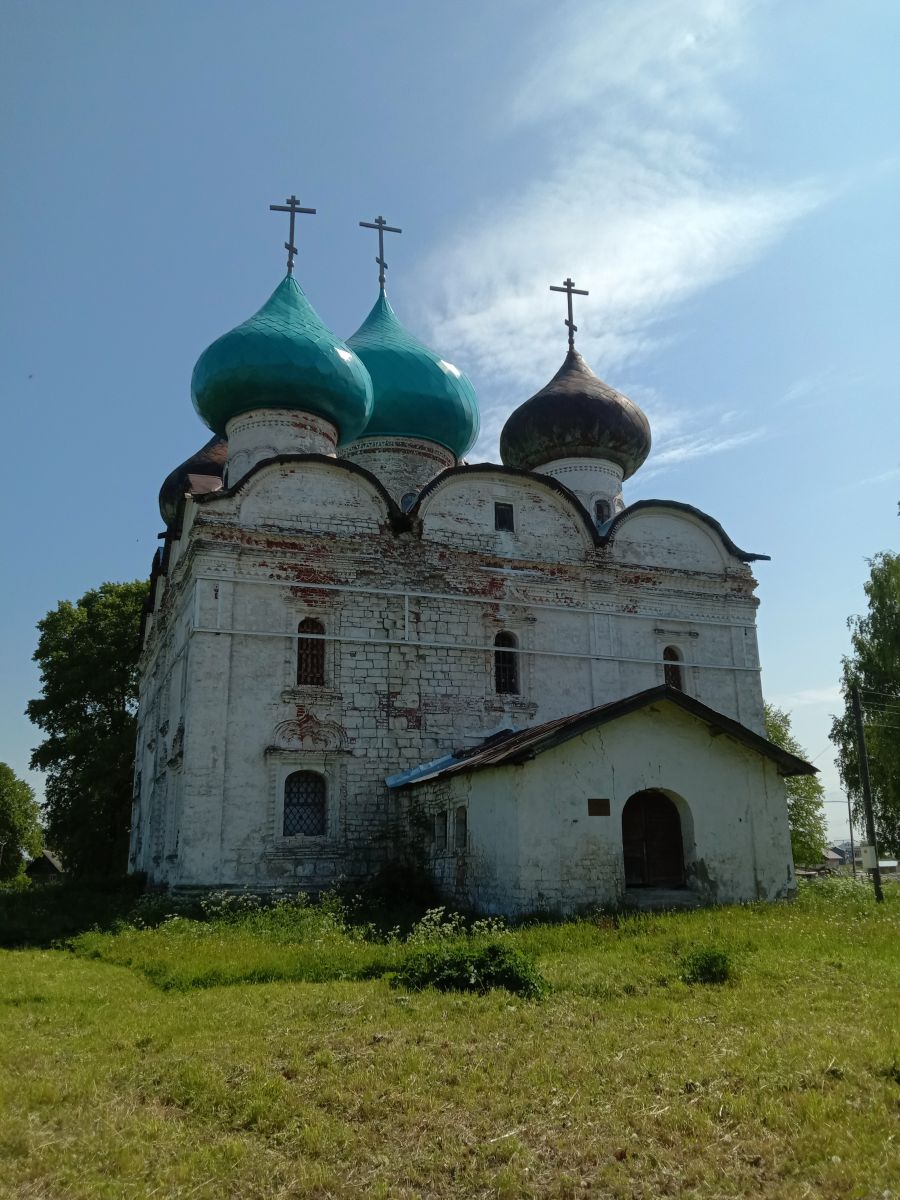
[344,290,480,458]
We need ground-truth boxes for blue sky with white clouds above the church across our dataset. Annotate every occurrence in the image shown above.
[0,0,900,839]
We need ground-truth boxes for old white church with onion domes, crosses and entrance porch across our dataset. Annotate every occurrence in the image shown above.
[130,197,815,916]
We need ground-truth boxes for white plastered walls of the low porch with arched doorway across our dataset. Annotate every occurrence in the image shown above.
[404,702,796,914]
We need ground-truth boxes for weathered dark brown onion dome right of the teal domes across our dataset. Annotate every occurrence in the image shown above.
[500,350,650,479]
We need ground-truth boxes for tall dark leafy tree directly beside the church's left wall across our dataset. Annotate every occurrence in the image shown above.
[26,580,149,876]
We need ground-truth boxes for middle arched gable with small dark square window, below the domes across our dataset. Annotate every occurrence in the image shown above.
[409,463,598,562]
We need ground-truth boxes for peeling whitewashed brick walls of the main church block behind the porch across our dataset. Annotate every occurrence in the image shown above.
[131,460,762,887]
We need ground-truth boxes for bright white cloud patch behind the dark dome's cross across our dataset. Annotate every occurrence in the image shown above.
[424,143,811,386]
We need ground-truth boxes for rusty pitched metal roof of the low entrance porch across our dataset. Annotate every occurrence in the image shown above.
[386,684,817,787]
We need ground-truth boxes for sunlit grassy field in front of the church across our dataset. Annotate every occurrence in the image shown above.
[0,881,900,1200]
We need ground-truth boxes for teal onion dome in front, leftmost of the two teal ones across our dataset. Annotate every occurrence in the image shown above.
[191,275,372,440]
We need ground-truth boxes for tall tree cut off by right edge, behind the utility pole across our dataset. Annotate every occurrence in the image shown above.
[829,553,900,854]
